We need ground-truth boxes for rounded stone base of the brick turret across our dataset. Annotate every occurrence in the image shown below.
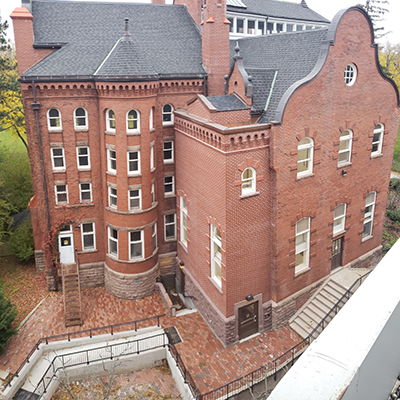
[104,263,159,300]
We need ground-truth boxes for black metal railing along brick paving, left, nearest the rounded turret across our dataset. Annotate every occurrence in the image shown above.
[4,314,165,387]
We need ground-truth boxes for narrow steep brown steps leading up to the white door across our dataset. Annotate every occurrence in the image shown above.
[61,263,82,328]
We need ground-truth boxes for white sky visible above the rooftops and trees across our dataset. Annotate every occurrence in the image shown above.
[0,0,400,43]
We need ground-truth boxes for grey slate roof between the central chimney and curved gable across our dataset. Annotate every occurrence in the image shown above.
[230,29,328,123]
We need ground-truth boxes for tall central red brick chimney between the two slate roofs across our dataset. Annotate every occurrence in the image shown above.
[201,0,230,96]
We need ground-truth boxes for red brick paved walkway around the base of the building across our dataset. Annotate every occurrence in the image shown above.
[0,287,301,393]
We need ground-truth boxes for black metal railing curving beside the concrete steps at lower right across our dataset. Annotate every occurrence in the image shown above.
[197,270,372,400]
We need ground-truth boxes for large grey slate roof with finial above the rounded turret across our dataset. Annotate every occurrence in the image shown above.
[23,0,205,79]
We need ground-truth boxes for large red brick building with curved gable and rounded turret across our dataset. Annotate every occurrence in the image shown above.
[11,0,399,345]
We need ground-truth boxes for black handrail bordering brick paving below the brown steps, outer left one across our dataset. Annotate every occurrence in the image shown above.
[4,314,166,386]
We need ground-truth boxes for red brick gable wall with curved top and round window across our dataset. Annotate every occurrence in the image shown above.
[271,11,399,302]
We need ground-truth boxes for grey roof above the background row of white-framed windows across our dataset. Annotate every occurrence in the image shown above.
[227,0,329,23]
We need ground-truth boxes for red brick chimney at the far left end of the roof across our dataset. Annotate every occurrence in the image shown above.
[11,7,52,75]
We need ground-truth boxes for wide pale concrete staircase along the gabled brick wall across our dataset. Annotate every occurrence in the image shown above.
[289,268,368,340]
